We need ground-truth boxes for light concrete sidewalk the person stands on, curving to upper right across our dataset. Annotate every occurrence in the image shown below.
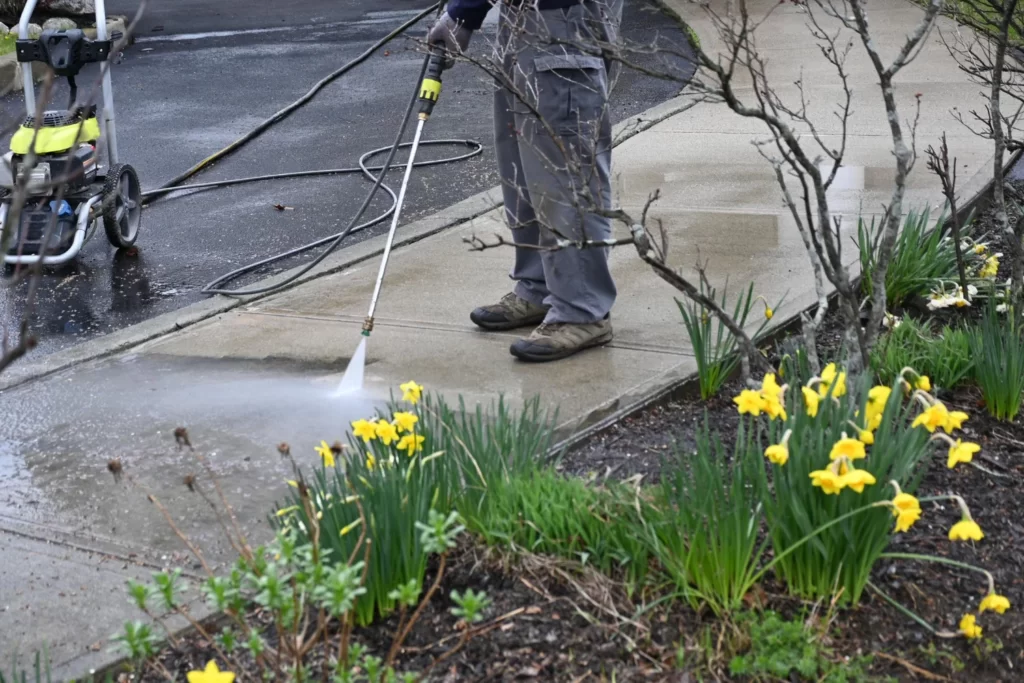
[0,0,990,673]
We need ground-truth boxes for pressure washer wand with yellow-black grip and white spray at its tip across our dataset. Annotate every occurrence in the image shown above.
[337,45,444,395]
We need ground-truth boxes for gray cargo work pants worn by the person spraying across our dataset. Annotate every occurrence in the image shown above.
[495,0,623,323]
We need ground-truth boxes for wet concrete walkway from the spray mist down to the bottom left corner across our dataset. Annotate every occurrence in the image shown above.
[0,355,386,680]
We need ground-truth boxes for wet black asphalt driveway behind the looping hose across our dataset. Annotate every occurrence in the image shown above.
[0,0,682,355]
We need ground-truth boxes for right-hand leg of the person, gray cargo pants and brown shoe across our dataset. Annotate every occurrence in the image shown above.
[512,0,622,360]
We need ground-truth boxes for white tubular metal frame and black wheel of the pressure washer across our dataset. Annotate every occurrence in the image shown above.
[0,0,141,265]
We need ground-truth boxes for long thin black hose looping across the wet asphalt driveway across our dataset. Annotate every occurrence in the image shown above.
[136,3,483,297]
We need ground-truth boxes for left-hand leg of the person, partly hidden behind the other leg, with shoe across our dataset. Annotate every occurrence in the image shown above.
[470,9,548,330]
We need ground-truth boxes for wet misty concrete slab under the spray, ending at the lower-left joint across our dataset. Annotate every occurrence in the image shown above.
[0,356,386,565]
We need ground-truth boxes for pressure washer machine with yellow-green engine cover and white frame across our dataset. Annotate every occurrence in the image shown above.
[0,0,142,265]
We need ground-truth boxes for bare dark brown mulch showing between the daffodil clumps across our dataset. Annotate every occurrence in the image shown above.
[119,301,1024,682]
